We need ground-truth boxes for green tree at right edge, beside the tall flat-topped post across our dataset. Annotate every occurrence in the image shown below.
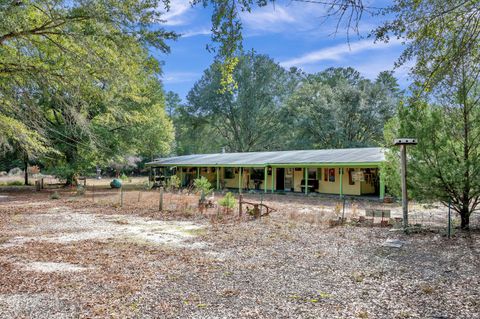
[384,61,480,228]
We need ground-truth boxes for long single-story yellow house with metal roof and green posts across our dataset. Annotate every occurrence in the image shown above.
[147,147,385,199]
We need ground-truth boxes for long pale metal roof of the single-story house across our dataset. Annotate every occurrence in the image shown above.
[147,147,385,167]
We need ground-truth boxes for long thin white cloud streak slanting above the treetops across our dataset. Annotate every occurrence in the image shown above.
[280,39,401,68]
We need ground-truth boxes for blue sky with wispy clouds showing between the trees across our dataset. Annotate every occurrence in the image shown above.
[152,0,409,99]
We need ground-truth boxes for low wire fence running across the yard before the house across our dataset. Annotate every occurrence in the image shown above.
[76,186,480,231]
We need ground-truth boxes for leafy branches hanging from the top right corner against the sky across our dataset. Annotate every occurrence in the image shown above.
[374,0,480,95]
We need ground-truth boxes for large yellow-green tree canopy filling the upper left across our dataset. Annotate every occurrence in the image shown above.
[0,0,175,183]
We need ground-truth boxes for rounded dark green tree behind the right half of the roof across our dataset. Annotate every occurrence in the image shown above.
[286,68,402,149]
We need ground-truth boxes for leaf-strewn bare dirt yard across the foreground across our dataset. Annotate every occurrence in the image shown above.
[0,189,480,318]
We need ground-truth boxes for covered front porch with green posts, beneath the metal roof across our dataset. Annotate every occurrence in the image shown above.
[148,163,385,199]
